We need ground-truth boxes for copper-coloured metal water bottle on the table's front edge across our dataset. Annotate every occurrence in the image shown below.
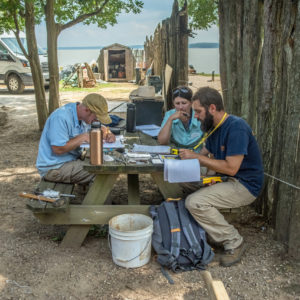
[90,122,103,165]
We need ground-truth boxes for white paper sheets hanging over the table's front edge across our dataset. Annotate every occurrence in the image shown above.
[164,159,201,183]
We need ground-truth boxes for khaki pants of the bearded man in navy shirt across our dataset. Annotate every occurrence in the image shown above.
[185,177,255,250]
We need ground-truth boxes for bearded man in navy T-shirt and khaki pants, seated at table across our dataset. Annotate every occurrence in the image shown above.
[179,87,263,267]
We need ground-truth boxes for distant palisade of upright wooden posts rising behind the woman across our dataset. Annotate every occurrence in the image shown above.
[144,0,189,110]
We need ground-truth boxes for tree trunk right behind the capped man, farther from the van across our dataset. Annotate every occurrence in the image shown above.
[45,0,59,113]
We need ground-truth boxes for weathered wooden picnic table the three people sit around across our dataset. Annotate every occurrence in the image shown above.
[34,131,181,247]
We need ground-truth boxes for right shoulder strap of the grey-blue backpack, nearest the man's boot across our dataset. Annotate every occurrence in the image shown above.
[178,200,202,258]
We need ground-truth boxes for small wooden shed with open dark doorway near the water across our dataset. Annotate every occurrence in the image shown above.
[98,43,136,81]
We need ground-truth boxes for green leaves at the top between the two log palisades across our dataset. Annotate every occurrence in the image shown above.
[179,0,218,30]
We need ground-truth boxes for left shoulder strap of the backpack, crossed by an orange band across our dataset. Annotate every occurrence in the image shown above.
[163,201,181,258]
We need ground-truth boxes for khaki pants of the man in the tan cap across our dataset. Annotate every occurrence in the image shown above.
[44,159,95,184]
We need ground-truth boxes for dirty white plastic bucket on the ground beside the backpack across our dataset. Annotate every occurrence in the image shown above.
[109,214,153,268]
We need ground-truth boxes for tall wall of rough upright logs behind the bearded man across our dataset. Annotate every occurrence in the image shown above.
[219,0,300,258]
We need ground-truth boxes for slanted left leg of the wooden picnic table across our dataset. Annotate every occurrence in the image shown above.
[60,174,118,248]
